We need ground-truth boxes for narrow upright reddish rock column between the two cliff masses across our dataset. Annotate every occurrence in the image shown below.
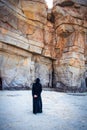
[43,21,56,58]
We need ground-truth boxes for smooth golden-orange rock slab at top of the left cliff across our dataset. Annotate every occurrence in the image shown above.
[21,0,47,24]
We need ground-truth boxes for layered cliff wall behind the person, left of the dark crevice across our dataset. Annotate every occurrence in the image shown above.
[0,0,54,89]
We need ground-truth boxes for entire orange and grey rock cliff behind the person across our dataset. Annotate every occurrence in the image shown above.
[0,0,87,90]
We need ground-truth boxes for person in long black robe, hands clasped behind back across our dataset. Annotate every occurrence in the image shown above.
[32,78,42,114]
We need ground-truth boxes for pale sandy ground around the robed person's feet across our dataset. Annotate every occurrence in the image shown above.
[0,91,87,130]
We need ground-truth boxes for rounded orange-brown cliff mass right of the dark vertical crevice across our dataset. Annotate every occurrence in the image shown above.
[53,0,87,89]
